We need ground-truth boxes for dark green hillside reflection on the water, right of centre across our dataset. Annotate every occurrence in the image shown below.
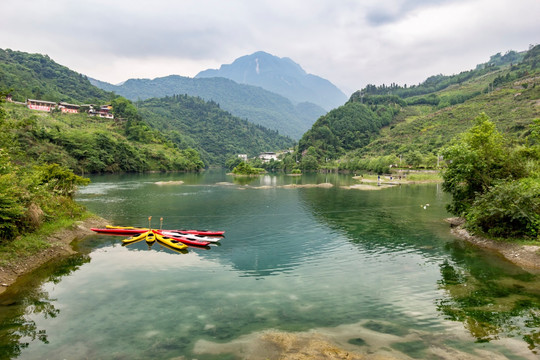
[301,185,449,257]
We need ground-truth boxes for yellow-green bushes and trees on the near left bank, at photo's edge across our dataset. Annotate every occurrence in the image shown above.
[0,100,94,243]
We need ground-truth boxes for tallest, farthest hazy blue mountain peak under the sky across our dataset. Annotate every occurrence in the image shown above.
[195,51,347,110]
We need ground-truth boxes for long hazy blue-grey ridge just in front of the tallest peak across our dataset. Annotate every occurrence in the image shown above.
[91,75,325,139]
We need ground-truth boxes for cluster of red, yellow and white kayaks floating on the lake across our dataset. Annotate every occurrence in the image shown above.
[92,225,225,250]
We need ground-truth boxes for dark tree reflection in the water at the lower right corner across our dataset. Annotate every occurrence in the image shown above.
[436,243,540,354]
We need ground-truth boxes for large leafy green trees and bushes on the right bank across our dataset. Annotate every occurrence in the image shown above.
[443,114,540,238]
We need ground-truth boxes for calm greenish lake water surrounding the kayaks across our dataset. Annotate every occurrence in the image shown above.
[0,171,540,359]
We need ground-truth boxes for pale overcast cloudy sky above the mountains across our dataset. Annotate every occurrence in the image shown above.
[0,0,540,95]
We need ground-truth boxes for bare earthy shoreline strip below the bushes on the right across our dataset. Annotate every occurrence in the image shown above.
[446,218,540,273]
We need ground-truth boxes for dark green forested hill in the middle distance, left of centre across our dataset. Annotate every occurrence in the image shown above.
[137,95,294,165]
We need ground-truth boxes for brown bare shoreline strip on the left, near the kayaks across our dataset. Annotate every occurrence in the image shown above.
[0,216,108,294]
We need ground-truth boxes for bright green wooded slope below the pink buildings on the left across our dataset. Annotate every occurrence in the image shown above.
[0,104,204,174]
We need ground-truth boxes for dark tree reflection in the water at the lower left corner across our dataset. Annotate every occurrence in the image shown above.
[0,255,90,359]
